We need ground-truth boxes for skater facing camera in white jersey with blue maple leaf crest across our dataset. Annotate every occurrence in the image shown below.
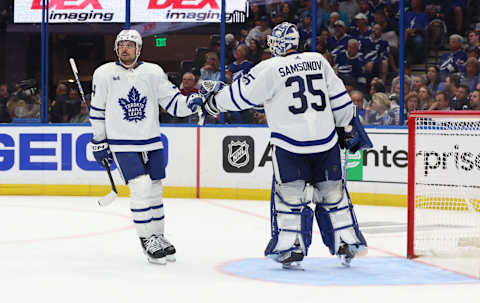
[90,30,200,264]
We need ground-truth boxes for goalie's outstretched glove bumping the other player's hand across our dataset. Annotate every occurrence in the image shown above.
[187,80,225,117]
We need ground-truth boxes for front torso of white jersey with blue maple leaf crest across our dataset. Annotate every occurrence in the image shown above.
[101,62,162,151]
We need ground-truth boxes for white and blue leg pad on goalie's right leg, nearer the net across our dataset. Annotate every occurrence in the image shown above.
[314,181,367,255]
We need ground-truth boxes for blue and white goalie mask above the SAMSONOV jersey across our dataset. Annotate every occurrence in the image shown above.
[267,22,299,56]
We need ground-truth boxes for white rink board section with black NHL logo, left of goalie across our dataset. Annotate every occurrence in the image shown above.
[200,127,273,189]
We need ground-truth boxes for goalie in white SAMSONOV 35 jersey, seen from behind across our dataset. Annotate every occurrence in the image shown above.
[190,22,371,268]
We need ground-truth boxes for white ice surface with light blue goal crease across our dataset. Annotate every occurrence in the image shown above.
[0,196,480,303]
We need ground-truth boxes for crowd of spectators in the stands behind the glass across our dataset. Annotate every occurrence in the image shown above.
[0,0,480,125]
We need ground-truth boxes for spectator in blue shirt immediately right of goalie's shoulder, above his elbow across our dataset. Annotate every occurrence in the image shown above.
[334,39,367,91]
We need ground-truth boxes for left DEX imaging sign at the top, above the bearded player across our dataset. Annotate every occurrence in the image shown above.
[13,0,124,23]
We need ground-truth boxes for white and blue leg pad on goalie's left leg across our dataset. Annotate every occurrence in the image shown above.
[265,180,313,259]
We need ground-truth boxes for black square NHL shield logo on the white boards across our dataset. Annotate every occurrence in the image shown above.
[223,136,255,173]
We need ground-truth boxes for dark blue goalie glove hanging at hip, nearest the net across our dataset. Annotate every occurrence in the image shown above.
[337,112,373,153]
